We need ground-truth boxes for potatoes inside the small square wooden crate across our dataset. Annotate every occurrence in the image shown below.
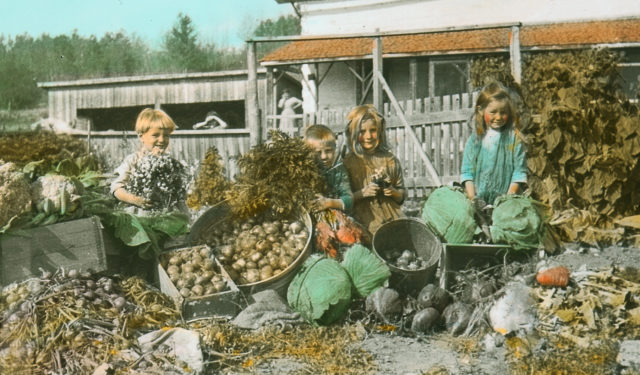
[160,245,228,298]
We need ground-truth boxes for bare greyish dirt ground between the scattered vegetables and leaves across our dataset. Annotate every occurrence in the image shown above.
[235,244,640,375]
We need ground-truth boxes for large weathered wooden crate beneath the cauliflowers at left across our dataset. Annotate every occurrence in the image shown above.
[0,216,119,285]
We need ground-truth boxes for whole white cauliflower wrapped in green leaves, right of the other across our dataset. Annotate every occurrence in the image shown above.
[31,175,84,215]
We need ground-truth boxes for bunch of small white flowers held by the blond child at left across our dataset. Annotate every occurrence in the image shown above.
[125,154,187,210]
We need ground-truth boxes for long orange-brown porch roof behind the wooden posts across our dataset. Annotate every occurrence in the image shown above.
[261,18,640,65]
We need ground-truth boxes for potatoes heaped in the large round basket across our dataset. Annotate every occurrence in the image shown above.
[205,217,310,285]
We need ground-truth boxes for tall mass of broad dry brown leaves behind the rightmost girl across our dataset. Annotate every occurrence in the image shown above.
[472,49,640,244]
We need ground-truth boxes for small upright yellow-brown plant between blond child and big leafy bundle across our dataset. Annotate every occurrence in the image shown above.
[187,146,231,210]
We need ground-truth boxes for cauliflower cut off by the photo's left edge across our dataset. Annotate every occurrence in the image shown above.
[0,160,31,228]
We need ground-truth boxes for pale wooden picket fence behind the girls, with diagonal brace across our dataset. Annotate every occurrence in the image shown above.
[267,93,476,197]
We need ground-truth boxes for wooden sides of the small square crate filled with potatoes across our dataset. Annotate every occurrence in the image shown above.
[156,245,246,320]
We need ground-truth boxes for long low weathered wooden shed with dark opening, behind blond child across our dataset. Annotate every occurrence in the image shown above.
[38,69,299,176]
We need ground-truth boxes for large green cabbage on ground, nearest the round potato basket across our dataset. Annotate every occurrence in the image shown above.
[287,255,352,325]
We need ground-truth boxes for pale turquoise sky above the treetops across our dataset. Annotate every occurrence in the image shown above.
[0,0,294,49]
